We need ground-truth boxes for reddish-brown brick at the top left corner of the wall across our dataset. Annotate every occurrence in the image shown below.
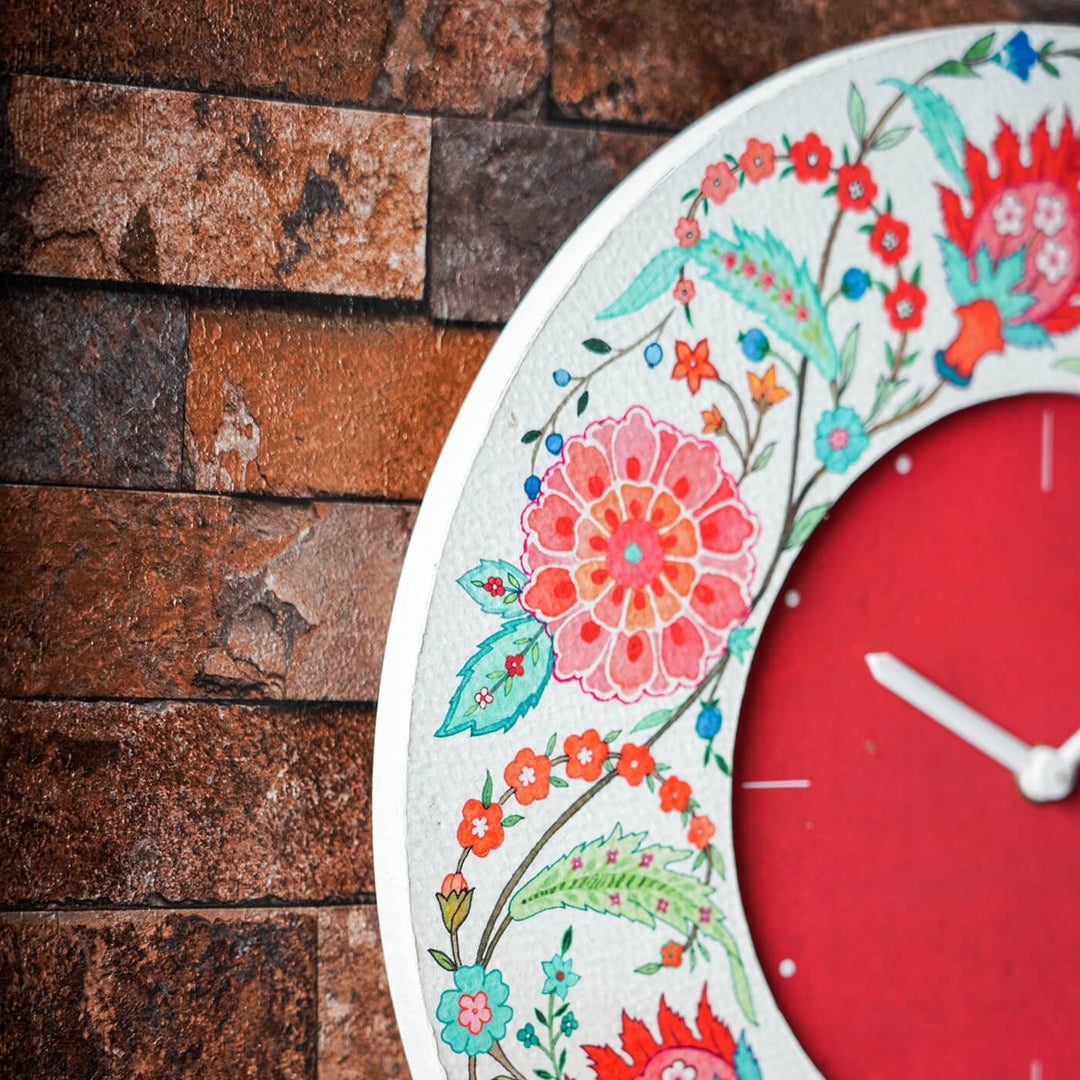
[0,0,548,117]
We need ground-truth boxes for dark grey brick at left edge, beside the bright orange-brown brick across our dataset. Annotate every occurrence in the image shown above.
[0,285,188,488]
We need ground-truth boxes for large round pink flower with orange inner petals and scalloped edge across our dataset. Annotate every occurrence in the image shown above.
[522,406,758,699]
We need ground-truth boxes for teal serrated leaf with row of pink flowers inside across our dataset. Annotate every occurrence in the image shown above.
[690,225,839,382]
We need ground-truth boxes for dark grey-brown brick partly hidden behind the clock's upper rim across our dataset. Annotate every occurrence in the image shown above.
[430,120,663,322]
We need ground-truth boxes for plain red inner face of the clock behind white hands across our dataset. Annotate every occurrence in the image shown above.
[733,395,1080,1080]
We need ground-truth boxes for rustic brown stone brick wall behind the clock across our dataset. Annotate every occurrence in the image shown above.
[0,0,1062,1080]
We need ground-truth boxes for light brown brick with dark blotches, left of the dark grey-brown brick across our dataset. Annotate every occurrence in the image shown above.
[0,76,431,298]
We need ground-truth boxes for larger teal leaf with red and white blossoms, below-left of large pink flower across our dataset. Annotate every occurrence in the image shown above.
[435,616,554,738]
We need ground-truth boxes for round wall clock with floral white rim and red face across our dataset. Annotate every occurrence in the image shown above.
[375,26,1080,1080]
